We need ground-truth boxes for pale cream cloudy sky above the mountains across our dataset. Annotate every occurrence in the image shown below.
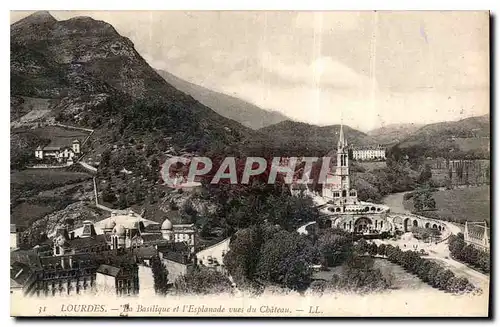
[11,11,489,131]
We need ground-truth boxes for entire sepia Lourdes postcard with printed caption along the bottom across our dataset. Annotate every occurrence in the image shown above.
[10,11,491,318]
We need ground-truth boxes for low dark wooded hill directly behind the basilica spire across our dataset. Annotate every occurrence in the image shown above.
[248,120,377,156]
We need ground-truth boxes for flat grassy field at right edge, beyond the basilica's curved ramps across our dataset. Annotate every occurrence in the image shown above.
[404,185,490,222]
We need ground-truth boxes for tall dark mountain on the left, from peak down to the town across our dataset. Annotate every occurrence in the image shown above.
[10,12,255,238]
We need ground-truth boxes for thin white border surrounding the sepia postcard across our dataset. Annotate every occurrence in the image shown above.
[0,0,500,326]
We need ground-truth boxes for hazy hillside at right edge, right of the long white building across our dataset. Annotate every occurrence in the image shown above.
[399,115,490,158]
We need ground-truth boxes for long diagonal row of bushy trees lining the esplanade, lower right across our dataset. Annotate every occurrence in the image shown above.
[377,245,476,293]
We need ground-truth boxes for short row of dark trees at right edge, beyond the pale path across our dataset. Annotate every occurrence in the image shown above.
[448,233,491,273]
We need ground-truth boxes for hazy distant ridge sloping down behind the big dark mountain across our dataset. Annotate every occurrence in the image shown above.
[157,70,289,130]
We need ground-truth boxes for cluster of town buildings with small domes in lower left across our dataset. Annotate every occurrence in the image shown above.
[10,210,229,296]
